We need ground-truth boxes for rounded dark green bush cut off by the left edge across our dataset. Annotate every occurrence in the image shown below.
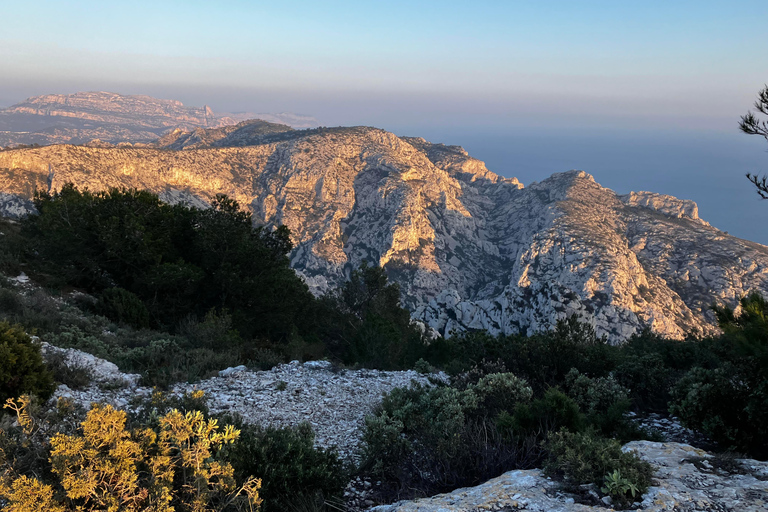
[0,322,54,403]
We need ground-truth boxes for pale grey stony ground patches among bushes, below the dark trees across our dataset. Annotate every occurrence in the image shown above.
[49,356,447,460]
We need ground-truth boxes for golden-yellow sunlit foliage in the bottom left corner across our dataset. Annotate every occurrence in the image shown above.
[0,403,261,512]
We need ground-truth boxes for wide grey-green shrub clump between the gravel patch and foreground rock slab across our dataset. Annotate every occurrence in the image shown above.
[361,374,537,499]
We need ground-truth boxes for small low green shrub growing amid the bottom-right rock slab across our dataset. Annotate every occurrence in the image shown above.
[544,430,653,505]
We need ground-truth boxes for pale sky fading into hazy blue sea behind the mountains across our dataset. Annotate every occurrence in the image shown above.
[0,0,768,240]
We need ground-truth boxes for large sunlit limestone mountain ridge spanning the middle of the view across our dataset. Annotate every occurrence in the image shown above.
[0,123,768,342]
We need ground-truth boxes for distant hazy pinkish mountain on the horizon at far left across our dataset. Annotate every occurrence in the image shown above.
[0,92,318,147]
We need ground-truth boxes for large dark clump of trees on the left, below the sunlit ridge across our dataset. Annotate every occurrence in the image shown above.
[22,185,313,338]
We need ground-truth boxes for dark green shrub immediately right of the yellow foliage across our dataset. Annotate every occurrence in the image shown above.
[220,418,347,512]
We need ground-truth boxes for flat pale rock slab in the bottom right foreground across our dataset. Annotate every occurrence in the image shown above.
[371,441,768,512]
